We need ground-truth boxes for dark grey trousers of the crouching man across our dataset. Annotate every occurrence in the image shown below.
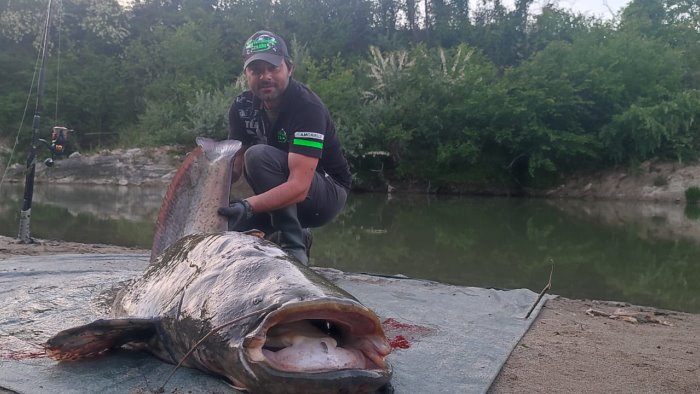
[232,144,347,249]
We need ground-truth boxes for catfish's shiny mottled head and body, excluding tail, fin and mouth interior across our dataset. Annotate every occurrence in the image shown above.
[114,232,391,393]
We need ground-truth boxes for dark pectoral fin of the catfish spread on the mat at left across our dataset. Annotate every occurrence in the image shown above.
[45,318,160,361]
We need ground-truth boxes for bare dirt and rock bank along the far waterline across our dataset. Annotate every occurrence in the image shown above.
[0,143,700,203]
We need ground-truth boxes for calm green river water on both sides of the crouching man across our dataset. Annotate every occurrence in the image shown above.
[0,184,700,313]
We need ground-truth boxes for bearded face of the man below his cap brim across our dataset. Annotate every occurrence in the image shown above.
[245,60,292,102]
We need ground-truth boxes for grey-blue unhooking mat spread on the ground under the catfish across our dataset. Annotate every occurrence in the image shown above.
[0,254,552,394]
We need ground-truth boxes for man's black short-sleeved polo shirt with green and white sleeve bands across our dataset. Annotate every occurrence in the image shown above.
[228,79,352,189]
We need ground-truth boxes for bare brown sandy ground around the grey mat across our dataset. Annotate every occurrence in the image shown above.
[0,236,700,394]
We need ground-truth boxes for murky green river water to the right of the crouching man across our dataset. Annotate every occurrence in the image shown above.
[313,195,700,311]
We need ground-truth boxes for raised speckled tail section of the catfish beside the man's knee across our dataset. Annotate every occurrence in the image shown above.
[151,137,241,260]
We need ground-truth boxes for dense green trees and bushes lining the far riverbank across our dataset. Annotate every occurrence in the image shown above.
[0,0,700,191]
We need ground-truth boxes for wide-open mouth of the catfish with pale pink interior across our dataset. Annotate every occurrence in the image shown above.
[246,303,391,373]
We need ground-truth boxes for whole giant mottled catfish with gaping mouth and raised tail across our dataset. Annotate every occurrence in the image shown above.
[46,139,392,393]
